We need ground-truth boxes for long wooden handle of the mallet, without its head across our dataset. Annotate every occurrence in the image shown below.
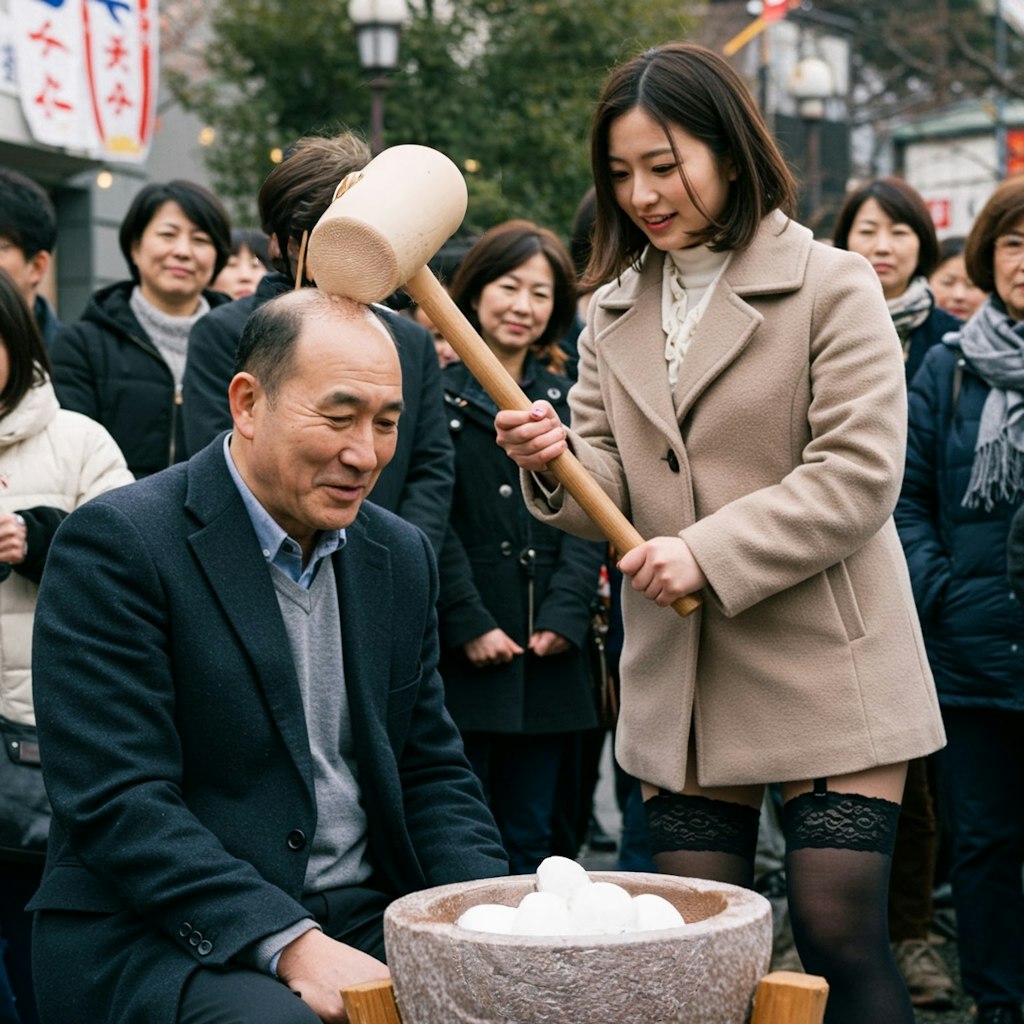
[402,266,700,615]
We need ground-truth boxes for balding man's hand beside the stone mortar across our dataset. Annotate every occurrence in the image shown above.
[278,929,391,1024]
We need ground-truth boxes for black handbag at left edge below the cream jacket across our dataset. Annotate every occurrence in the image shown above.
[0,715,50,861]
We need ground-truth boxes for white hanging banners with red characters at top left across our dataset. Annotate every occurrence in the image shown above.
[8,0,159,163]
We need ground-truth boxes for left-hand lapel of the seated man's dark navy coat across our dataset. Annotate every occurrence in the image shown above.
[185,436,312,788]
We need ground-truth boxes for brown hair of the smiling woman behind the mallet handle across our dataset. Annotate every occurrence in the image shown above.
[450,220,575,372]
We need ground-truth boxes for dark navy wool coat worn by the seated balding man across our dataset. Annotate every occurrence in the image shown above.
[24,439,507,1024]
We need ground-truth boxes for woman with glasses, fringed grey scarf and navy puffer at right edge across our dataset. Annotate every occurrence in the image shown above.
[896,178,1024,1024]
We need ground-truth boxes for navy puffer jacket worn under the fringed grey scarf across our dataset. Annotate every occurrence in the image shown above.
[896,344,1024,711]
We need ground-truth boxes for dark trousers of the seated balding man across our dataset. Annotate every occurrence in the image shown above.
[178,886,392,1024]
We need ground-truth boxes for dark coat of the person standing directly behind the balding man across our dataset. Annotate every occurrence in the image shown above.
[182,272,455,552]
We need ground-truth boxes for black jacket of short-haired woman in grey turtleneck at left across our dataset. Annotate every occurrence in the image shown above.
[50,281,230,476]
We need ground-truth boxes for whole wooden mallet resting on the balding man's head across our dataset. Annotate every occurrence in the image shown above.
[306,145,700,615]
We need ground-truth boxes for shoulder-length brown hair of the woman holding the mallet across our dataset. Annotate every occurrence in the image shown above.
[583,43,796,288]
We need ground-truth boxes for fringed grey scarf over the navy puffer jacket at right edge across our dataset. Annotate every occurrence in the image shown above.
[943,295,1024,512]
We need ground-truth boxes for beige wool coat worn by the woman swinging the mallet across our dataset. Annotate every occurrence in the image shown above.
[523,211,944,791]
